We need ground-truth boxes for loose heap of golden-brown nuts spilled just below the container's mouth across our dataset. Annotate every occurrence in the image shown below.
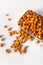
[11,30,33,54]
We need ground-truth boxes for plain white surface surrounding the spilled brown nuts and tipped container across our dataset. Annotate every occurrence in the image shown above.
[0,0,43,65]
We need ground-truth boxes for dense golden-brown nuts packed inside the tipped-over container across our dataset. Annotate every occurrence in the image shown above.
[18,10,43,39]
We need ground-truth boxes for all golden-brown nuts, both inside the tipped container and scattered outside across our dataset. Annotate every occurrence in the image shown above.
[0,10,43,54]
